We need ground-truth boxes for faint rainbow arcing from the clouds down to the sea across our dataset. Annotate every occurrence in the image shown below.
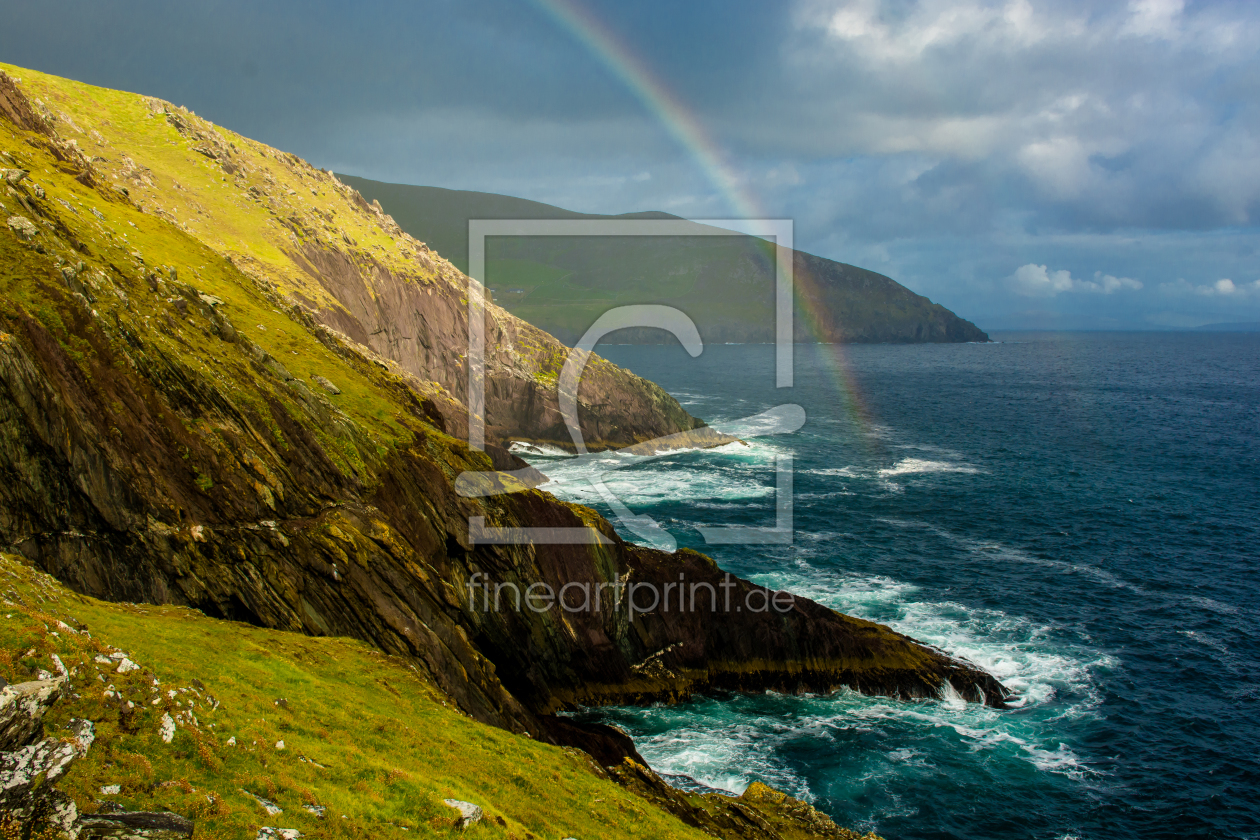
[534,0,876,445]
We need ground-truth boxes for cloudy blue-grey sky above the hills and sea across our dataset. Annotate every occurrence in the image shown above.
[0,0,1260,330]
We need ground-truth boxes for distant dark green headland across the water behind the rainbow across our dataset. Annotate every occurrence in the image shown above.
[340,175,988,344]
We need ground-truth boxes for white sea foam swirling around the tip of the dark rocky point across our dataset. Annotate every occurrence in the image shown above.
[624,563,1115,798]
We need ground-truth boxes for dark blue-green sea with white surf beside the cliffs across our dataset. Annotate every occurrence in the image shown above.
[521,334,1260,840]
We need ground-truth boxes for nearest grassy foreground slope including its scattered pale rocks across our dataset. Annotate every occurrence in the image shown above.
[0,554,873,840]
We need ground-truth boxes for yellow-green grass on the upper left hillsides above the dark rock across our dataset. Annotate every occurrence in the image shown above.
[0,65,491,478]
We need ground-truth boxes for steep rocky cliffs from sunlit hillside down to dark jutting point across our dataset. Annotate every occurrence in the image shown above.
[0,64,1005,760]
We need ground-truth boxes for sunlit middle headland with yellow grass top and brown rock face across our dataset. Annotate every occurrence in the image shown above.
[0,68,701,448]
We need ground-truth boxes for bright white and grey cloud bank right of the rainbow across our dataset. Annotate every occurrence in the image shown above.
[781,0,1260,230]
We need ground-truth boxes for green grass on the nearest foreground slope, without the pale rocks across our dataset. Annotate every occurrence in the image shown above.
[0,555,704,840]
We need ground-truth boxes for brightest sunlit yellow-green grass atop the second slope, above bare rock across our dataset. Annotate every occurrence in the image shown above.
[0,64,432,312]
